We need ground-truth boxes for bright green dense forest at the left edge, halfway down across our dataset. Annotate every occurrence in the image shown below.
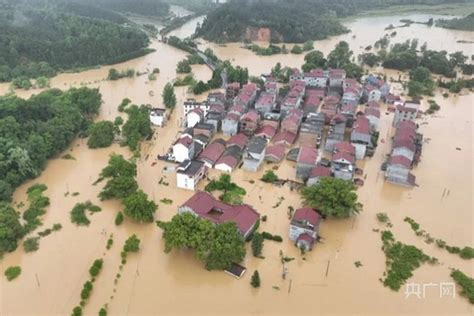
[0,87,102,201]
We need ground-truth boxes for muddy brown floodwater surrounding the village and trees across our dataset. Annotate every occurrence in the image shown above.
[0,12,474,315]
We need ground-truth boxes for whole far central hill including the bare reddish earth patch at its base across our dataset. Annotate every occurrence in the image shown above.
[196,0,347,43]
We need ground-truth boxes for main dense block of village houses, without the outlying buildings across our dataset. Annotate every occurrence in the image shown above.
[171,69,390,190]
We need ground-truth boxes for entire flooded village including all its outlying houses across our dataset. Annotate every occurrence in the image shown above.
[154,69,423,251]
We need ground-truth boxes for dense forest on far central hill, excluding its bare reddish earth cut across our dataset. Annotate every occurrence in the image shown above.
[197,0,467,43]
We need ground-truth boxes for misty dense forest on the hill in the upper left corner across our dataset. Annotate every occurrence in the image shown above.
[0,4,149,82]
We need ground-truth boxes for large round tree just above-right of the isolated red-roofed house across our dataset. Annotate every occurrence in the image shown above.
[301,178,362,218]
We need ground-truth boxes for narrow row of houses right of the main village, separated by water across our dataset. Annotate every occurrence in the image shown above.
[385,101,423,186]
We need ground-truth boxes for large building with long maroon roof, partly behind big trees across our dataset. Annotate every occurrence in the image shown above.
[178,192,260,239]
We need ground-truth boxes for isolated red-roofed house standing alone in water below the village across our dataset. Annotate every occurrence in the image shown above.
[288,207,322,251]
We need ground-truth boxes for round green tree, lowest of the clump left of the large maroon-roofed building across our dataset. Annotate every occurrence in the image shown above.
[123,190,158,223]
